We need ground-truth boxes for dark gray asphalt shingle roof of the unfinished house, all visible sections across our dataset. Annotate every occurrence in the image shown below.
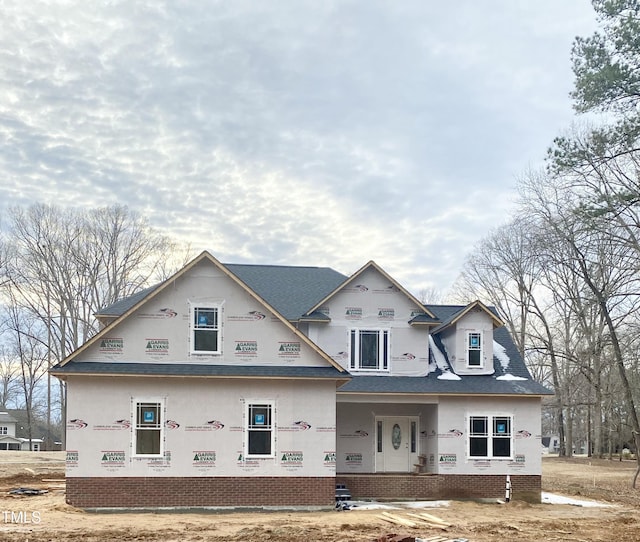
[86,264,551,395]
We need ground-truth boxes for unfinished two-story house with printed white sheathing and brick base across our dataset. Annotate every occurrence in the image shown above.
[52,252,550,507]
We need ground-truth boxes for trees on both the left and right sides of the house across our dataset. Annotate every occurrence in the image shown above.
[0,0,640,492]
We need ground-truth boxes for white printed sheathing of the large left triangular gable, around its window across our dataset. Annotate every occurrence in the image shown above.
[75,261,327,366]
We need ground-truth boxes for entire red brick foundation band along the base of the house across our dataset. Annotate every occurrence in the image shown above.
[67,474,542,508]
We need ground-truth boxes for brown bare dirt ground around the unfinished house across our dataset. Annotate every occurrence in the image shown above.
[0,452,640,542]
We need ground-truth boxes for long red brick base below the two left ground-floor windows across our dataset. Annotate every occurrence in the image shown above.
[66,477,335,508]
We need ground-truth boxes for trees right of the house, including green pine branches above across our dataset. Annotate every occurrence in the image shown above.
[459,0,640,485]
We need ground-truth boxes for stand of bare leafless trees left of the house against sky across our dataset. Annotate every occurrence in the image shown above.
[0,204,189,447]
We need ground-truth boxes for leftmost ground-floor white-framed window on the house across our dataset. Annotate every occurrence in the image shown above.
[131,399,164,457]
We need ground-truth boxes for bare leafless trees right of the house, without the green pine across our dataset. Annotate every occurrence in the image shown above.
[462,154,640,468]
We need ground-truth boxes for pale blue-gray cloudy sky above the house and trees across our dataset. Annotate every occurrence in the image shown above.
[0,0,596,293]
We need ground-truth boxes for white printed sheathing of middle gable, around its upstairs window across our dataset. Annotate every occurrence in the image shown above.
[309,268,429,376]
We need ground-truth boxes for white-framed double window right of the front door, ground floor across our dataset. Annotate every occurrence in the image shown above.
[468,416,513,459]
